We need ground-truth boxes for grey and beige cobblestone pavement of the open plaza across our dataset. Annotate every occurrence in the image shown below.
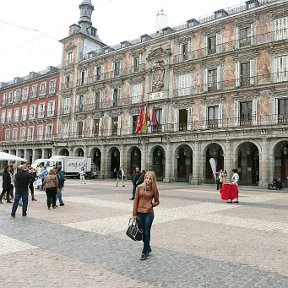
[0,179,288,288]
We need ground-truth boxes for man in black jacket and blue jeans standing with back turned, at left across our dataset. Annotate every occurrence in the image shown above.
[11,165,33,218]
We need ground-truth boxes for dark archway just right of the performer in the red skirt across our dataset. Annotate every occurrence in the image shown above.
[234,142,259,185]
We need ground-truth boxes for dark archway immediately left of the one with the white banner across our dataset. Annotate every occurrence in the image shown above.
[176,145,192,182]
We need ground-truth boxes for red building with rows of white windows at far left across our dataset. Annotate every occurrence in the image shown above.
[0,66,60,168]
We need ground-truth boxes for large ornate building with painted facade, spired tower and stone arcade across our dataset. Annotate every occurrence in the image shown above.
[0,0,288,187]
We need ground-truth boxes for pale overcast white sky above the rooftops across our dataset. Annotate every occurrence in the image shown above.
[0,0,245,82]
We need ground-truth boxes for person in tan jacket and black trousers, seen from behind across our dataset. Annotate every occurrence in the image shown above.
[43,169,58,210]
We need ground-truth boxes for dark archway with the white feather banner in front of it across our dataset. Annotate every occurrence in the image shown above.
[205,143,225,184]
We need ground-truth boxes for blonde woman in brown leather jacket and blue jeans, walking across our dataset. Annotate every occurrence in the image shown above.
[132,171,160,260]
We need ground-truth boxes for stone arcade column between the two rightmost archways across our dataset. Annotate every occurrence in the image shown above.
[259,139,273,188]
